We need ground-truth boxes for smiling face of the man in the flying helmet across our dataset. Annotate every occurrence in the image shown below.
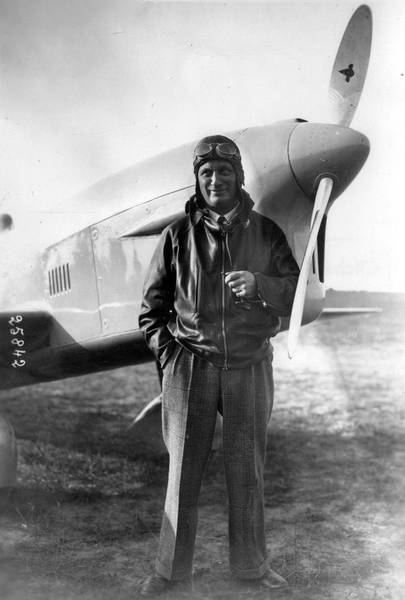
[198,160,238,214]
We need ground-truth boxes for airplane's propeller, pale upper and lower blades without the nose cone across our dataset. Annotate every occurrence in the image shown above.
[287,5,372,358]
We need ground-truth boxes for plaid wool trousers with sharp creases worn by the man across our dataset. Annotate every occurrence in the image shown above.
[156,346,273,580]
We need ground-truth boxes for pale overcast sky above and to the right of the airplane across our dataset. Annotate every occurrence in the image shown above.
[0,0,405,291]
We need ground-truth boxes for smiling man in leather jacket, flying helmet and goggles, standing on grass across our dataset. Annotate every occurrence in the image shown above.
[139,135,299,596]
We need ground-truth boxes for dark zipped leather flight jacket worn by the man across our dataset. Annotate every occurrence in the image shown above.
[139,190,299,369]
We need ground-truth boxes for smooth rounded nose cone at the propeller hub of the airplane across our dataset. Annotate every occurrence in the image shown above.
[288,123,370,200]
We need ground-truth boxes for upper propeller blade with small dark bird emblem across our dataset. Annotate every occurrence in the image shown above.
[329,4,373,127]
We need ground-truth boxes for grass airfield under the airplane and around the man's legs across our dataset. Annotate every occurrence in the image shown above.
[0,296,405,600]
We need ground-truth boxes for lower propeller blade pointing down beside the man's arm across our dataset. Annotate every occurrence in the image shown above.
[287,177,333,358]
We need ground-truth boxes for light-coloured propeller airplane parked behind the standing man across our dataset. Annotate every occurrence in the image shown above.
[0,5,372,488]
